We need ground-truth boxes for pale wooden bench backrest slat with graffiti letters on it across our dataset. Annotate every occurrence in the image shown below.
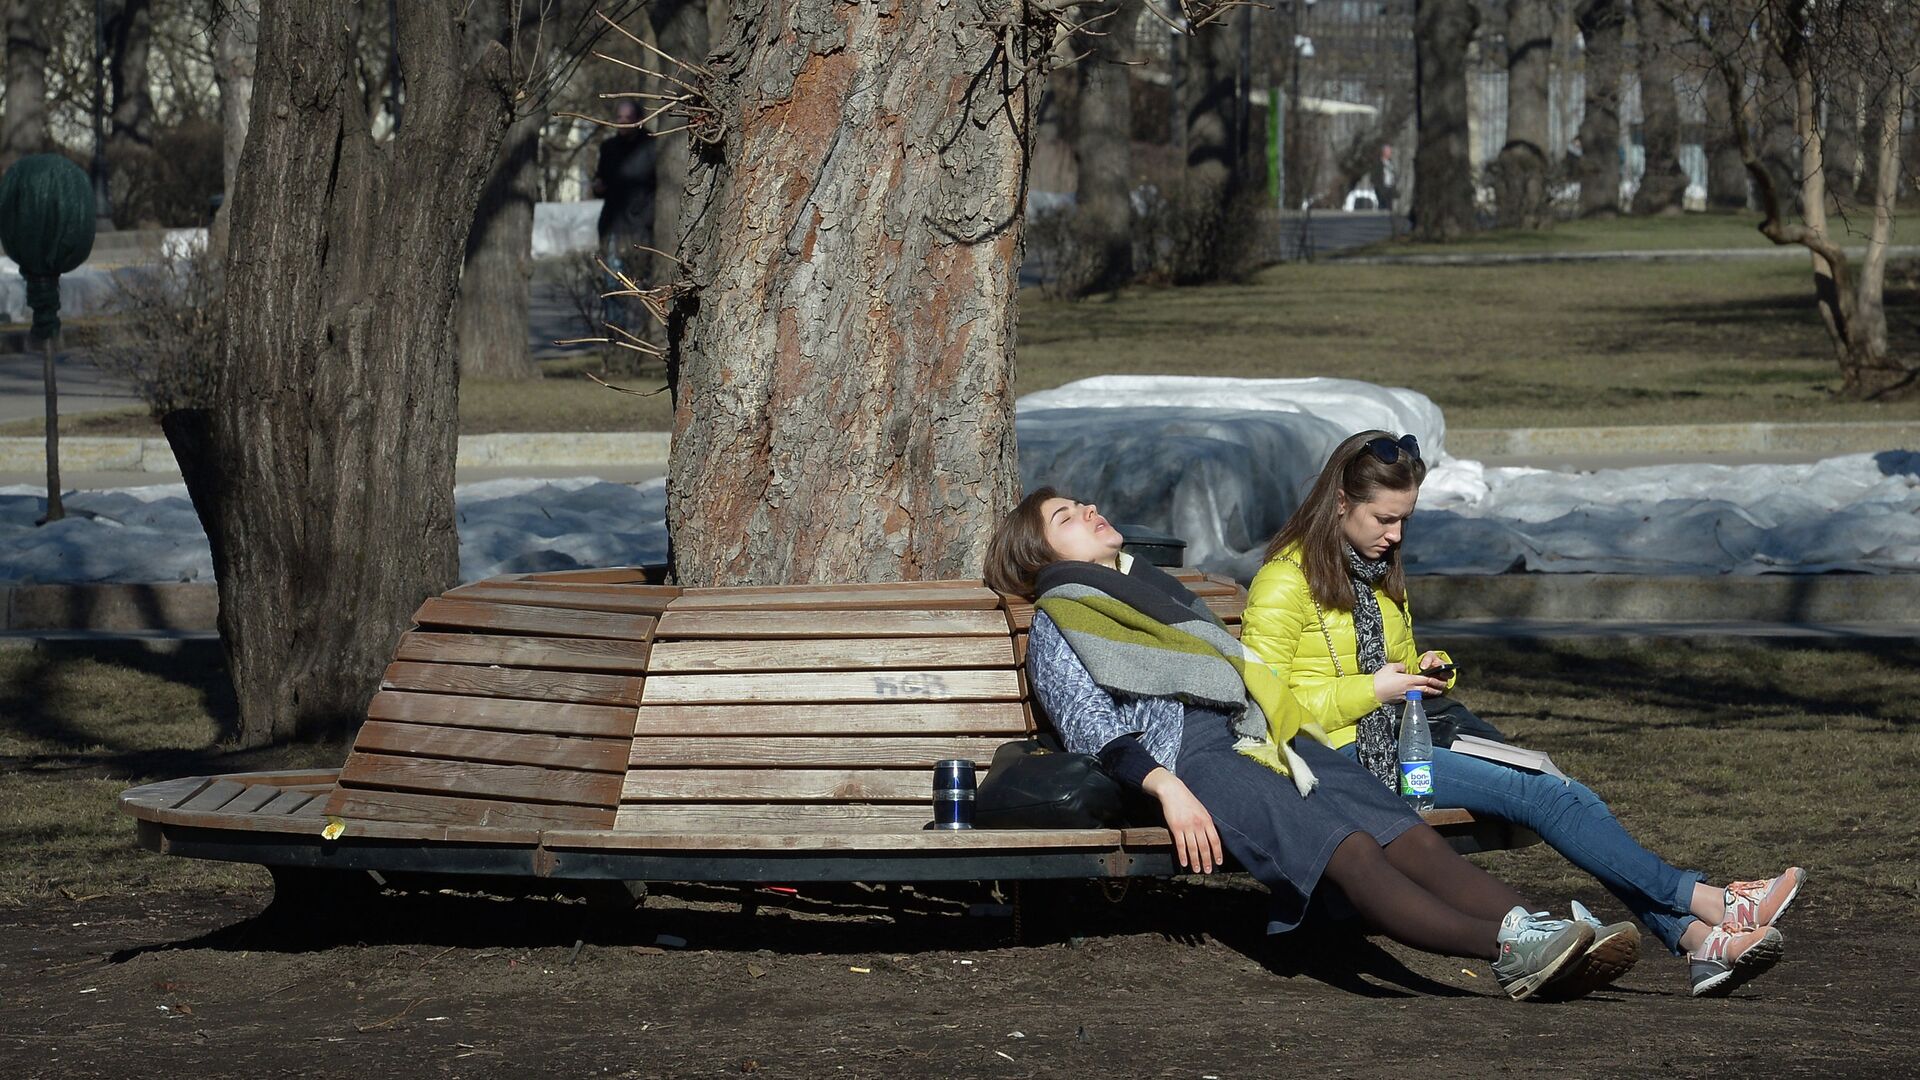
[641,667,1020,705]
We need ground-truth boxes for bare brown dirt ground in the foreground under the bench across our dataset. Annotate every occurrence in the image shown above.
[0,864,1920,1080]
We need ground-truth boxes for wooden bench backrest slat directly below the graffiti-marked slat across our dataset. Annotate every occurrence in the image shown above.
[634,701,1025,738]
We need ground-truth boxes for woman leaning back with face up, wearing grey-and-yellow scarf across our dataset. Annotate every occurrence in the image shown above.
[987,488,1638,999]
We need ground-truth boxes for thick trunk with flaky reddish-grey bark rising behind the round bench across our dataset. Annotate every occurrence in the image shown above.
[666,0,1050,586]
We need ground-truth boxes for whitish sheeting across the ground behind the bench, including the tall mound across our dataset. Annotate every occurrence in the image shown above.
[0,379,1920,582]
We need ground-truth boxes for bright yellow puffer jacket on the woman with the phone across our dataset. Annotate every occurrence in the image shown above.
[1240,546,1457,748]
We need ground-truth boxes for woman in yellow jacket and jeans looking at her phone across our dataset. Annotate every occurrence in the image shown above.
[1240,430,1803,995]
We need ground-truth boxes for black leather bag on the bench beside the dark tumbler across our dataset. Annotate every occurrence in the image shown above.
[973,736,1127,828]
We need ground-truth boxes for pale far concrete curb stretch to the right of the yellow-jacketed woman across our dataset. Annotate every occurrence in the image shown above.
[1446,421,1920,457]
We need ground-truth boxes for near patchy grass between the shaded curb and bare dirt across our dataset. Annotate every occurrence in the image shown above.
[0,642,1920,911]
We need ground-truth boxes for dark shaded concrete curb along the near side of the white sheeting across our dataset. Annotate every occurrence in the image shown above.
[11,575,1920,636]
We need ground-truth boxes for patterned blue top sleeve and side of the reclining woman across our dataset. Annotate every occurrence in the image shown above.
[1027,611,1187,773]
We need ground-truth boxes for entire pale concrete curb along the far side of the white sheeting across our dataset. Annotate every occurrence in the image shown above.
[0,421,1920,477]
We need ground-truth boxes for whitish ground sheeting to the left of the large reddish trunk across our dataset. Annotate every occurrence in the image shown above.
[0,479,666,582]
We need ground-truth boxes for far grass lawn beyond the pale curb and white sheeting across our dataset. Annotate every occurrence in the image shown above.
[0,215,1920,434]
